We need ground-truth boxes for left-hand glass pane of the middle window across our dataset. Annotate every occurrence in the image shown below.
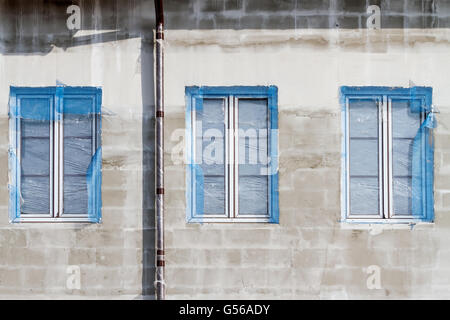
[195,99,226,216]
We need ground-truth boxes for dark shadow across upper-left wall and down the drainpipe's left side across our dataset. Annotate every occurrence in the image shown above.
[0,0,155,298]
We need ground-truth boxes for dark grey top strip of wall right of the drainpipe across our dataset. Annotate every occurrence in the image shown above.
[165,0,450,29]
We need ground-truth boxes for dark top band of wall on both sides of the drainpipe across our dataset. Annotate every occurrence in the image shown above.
[0,0,450,54]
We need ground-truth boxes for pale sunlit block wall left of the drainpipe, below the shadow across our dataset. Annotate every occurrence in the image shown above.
[0,38,149,299]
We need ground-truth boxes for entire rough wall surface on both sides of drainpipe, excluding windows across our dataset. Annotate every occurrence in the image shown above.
[0,0,450,298]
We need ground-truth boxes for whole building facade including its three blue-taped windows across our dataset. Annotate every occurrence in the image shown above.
[0,0,450,299]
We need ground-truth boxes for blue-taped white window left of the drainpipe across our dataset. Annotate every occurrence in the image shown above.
[9,87,101,222]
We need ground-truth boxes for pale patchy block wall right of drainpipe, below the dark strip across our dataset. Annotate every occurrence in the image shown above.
[165,29,450,299]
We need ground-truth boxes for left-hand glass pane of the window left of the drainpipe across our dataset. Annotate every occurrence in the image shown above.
[20,97,52,215]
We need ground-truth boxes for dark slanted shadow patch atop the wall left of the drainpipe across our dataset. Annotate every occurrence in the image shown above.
[0,0,155,54]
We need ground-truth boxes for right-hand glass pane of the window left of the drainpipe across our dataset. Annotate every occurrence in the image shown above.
[63,98,96,214]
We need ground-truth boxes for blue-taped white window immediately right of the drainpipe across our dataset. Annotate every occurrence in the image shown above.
[186,86,278,223]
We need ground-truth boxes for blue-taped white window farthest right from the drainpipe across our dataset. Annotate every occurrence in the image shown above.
[341,87,435,223]
